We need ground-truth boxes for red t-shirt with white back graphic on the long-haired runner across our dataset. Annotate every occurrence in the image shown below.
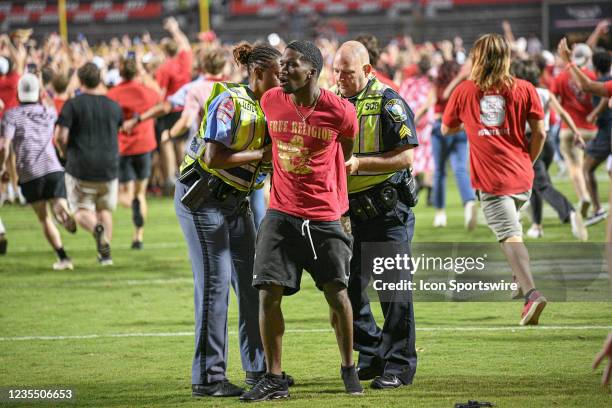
[442,79,544,195]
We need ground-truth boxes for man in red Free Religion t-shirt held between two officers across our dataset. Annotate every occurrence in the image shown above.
[247,41,363,401]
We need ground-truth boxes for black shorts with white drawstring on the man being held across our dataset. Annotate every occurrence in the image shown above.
[253,210,353,296]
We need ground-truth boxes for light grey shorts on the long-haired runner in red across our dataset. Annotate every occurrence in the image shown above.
[478,191,531,242]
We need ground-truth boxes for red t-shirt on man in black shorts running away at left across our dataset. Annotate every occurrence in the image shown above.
[106,81,160,156]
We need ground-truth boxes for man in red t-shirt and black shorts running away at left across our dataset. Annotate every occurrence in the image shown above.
[107,59,160,249]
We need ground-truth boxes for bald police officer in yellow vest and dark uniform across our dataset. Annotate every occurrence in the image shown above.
[333,41,418,389]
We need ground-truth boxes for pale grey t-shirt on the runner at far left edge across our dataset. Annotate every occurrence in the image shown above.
[0,103,63,184]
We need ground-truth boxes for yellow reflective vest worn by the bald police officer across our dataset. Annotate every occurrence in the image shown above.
[333,78,396,194]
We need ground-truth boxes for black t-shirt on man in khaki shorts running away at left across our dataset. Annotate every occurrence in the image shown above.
[57,94,123,181]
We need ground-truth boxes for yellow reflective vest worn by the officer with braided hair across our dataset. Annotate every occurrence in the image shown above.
[181,82,266,191]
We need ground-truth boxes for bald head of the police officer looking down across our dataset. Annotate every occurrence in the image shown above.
[333,41,372,98]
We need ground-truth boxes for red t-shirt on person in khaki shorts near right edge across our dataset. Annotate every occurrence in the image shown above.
[553,68,597,130]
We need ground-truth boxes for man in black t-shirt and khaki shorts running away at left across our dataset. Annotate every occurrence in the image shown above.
[57,62,123,266]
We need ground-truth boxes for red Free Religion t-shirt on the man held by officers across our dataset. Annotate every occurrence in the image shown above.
[260,88,359,221]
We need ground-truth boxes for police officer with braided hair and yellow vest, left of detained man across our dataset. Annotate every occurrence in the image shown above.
[174,43,281,397]
